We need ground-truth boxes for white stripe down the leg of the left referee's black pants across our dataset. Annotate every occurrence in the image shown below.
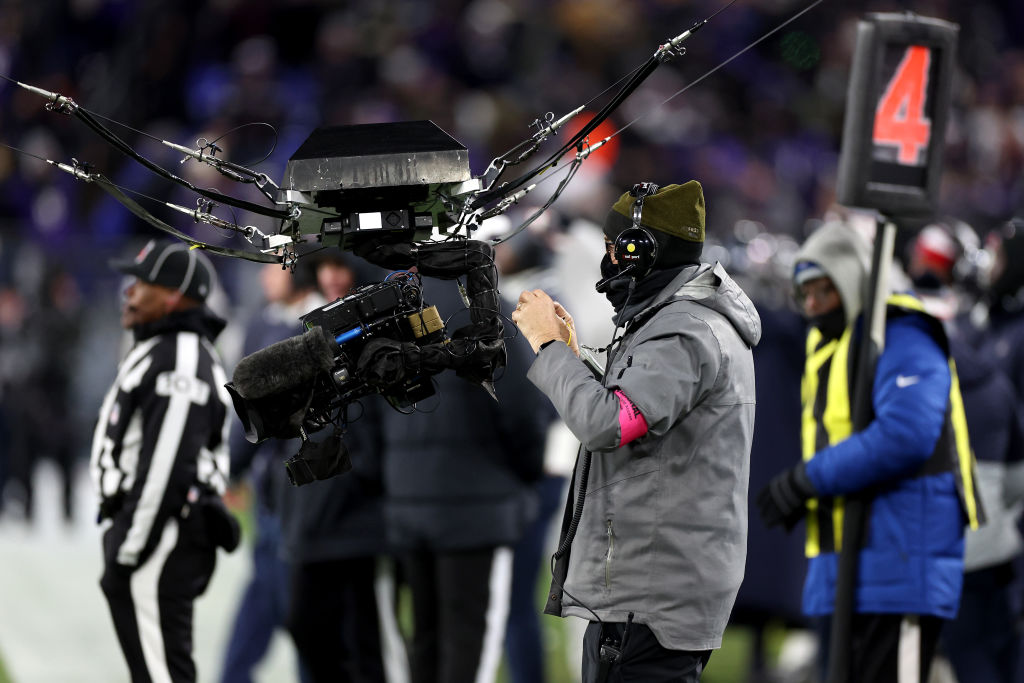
[131,518,178,683]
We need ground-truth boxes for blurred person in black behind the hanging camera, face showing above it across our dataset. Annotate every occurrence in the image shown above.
[282,255,409,683]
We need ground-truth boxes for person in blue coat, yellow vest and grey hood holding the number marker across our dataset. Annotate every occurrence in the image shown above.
[758,222,981,683]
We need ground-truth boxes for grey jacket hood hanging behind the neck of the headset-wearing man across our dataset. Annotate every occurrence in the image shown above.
[651,262,761,346]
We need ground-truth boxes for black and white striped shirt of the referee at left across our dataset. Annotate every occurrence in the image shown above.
[90,308,231,566]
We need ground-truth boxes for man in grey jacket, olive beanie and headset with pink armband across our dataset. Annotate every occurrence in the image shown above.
[513,180,761,683]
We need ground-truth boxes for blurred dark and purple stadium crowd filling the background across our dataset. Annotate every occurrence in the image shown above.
[0,0,1024,679]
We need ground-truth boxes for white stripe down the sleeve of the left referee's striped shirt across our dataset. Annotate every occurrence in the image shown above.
[118,332,199,565]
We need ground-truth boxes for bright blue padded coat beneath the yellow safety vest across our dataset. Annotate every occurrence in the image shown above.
[804,315,967,618]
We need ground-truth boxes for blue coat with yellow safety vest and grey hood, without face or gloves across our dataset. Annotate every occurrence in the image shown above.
[797,223,981,618]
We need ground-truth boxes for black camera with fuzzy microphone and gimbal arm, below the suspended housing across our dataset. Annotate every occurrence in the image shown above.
[227,241,505,484]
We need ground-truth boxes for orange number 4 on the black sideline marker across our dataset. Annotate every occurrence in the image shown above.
[873,45,932,165]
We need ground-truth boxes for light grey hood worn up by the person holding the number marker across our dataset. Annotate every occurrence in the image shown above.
[794,221,871,325]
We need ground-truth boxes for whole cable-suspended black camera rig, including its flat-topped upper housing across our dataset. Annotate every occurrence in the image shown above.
[227,122,505,484]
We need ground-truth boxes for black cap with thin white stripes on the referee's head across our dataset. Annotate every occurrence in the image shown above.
[111,240,216,301]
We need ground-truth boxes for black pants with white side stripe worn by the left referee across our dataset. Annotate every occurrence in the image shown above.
[99,519,217,683]
